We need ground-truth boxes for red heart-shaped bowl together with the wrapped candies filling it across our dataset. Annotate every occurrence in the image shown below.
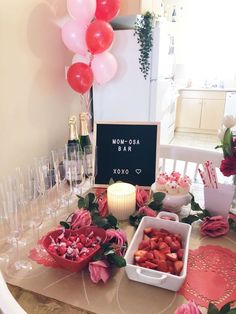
[43,226,106,272]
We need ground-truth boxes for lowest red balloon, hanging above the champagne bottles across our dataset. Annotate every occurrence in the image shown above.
[67,62,93,94]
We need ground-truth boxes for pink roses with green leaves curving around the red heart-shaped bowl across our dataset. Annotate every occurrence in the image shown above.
[60,191,127,283]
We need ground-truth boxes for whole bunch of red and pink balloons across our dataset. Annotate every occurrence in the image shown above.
[62,0,120,94]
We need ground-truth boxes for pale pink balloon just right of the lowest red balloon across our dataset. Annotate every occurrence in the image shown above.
[91,51,117,85]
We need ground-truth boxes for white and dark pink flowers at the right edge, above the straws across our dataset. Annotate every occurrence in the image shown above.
[215,115,236,177]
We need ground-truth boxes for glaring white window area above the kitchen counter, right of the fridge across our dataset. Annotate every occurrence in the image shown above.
[182,0,236,80]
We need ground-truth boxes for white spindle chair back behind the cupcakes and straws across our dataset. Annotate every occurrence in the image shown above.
[159,145,223,182]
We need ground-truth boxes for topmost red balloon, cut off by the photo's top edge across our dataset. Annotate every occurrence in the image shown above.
[95,0,120,21]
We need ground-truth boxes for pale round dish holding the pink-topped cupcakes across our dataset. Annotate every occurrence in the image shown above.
[151,183,191,213]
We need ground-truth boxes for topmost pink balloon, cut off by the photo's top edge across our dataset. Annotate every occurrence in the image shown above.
[67,0,96,25]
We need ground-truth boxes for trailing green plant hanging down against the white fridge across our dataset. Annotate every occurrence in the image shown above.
[134,12,155,80]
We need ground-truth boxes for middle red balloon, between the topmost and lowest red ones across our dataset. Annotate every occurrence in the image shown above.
[86,20,114,54]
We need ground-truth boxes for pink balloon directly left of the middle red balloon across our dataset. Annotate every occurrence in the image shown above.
[62,20,88,55]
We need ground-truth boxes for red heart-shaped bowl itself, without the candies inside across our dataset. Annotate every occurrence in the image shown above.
[43,226,106,272]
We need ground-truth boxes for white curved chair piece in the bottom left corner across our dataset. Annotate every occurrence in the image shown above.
[0,271,27,314]
